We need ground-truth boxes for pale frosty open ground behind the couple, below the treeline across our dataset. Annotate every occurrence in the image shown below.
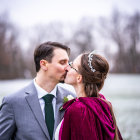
[0,74,140,140]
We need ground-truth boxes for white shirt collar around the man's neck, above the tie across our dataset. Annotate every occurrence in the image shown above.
[34,79,57,99]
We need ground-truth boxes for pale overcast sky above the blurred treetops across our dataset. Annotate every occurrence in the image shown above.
[0,0,140,27]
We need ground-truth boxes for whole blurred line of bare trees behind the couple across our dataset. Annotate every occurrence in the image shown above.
[0,10,140,79]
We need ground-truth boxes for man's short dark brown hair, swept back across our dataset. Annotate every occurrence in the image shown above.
[34,41,70,72]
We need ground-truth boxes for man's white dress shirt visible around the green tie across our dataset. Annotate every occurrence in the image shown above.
[34,79,57,120]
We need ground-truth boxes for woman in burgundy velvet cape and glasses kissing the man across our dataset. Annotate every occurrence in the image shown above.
[55,51,122,140]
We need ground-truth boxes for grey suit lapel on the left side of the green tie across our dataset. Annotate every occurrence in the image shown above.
[25,83,50,139]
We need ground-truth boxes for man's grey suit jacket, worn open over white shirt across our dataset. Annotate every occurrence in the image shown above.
[0,82,75,140]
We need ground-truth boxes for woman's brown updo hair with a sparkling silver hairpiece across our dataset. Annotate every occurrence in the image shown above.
[79,53,109,97]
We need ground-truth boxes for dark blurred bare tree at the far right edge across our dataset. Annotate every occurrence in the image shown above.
[125,13,140,73]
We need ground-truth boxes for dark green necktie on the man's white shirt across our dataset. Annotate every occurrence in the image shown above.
[42,94,54,140]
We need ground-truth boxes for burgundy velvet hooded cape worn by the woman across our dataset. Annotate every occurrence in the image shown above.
[59,95,122,140]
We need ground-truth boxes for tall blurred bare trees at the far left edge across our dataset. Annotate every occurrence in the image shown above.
[0,14,24,79]
